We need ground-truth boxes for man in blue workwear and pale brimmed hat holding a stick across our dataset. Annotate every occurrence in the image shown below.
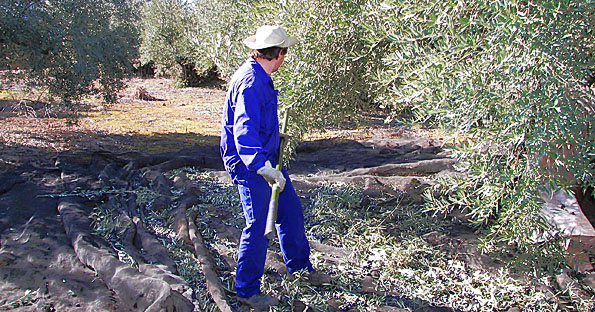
[220,26,328,309]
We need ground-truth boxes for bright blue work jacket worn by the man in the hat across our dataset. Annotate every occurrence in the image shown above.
[220,58,279,181]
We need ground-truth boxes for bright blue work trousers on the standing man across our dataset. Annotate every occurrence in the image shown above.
[235,169,312,298]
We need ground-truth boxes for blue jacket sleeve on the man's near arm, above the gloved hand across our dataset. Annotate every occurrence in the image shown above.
[233,83,266,171]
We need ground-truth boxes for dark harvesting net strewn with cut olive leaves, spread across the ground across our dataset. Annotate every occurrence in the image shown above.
[0,78,593,311]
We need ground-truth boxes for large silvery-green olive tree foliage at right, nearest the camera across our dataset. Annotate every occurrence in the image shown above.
[360,0,595,254]
